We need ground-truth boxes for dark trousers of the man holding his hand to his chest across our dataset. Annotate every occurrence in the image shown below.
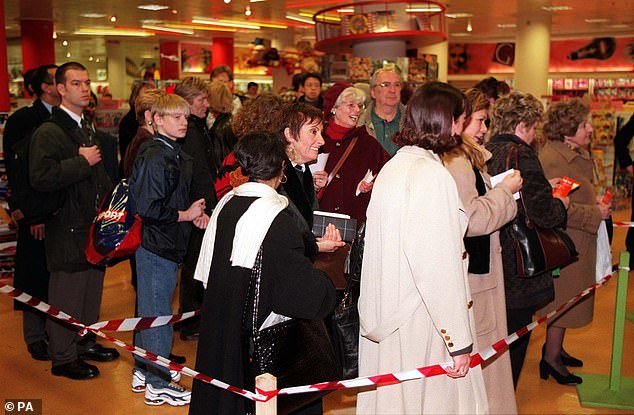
[46,268,104,366]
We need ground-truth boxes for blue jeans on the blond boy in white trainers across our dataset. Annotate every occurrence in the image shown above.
[134,246,178,387]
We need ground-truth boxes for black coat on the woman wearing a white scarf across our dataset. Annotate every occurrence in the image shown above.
[189,196,336,415]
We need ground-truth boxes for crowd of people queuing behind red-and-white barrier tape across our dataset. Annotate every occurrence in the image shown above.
[4,62,611,414]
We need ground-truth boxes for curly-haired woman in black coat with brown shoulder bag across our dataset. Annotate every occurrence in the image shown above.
[486,92,569,387]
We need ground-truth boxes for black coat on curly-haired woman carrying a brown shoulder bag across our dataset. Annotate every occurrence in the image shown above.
[486,134,567,309]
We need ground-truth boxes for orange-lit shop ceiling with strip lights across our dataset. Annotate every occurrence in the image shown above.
[4,0,634,45]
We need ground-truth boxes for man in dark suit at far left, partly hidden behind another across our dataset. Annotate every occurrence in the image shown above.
[3,65,59,360]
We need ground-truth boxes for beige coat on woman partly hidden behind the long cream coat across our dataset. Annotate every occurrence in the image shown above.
[445,153,517,414]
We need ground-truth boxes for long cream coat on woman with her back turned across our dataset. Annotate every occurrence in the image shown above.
[357,146,488,414]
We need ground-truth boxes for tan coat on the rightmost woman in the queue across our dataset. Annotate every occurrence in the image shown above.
[539,141,601,328]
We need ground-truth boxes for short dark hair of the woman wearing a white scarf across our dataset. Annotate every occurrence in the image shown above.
[233,130,286,182]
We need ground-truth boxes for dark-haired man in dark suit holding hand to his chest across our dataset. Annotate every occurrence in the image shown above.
[29,62,119,379]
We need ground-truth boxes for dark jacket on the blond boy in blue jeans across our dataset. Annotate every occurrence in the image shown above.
[130,134,193,262]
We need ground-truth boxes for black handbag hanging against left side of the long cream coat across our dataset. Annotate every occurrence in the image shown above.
[332,223,365,379]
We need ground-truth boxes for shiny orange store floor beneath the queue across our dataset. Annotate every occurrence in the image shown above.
[0,211,634,415]
